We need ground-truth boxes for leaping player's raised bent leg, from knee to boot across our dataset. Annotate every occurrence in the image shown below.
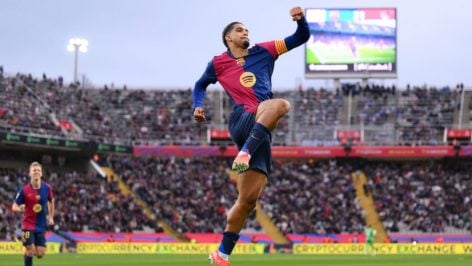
[232,99,290,172]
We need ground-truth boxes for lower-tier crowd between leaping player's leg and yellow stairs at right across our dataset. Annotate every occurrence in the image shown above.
[261,160,364,234]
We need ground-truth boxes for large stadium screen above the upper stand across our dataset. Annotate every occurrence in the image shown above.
[305,8,397,78]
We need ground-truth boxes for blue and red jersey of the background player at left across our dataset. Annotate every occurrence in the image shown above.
[15,182,53,232]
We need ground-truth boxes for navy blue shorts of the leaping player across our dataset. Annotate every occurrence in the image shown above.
[228,105,272,177]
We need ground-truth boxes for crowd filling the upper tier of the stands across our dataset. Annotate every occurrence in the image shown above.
[0,70,472,146]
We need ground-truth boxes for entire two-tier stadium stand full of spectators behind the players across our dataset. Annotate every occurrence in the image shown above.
[0,71,472,245]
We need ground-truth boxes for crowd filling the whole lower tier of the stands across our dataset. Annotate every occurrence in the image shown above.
[0,156,472,239]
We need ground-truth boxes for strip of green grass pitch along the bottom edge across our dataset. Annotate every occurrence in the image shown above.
[0,254,472,266]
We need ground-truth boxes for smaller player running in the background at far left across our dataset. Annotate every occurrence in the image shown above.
[12,162,54,266]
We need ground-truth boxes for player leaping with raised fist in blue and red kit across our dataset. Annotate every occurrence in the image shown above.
[193,7,310,266]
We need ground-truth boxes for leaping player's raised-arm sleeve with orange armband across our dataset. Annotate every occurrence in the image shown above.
[254,17,310,58]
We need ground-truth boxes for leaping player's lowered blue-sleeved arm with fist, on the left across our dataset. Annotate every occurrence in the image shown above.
[193,61,217,122]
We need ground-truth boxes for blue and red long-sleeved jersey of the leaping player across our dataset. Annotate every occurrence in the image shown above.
[193,18,310,113]
